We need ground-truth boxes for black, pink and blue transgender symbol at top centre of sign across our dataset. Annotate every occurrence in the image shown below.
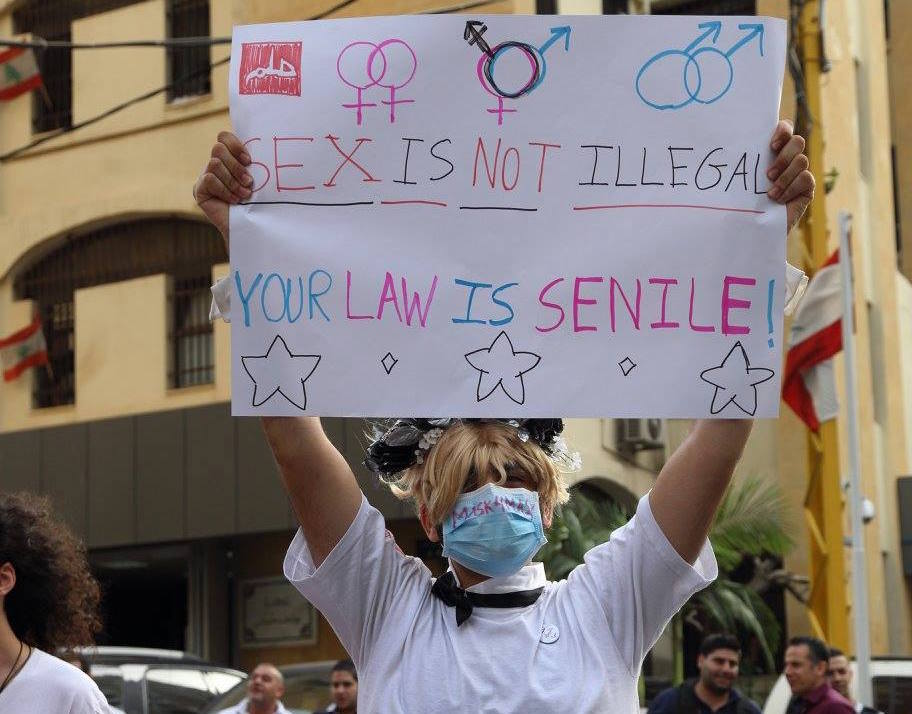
[463,20,570,125]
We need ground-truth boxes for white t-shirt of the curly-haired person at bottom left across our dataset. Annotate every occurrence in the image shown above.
[0,649,111,714]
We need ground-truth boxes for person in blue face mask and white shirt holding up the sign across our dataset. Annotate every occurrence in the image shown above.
[194,122,814,713]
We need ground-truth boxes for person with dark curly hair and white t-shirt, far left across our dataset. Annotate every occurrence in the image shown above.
[0,493,111,714]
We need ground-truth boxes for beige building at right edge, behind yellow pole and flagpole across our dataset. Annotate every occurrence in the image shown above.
[636,0,912,656]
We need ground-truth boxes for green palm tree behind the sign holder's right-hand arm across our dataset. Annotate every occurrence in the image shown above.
[538,477,794,671]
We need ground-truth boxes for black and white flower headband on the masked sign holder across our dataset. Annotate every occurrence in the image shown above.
[364,419,581,478]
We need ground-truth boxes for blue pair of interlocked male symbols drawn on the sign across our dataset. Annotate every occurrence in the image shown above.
[636,20,763,109]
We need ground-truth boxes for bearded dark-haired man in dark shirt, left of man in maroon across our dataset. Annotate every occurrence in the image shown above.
[648,635,760,714]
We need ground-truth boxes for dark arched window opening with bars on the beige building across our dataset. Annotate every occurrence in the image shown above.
[14,218,228,408]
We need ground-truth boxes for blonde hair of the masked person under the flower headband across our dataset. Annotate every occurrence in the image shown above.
[388,422,570,524]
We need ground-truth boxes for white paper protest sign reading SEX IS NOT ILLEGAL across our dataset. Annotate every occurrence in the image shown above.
[229,16,786,417]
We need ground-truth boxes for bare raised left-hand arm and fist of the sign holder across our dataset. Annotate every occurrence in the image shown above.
[193,131,361,567]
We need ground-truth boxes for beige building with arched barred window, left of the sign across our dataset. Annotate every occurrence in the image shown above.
[0,0,670,680]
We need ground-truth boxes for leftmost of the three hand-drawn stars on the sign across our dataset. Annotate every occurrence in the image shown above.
[241,335,320,411]
